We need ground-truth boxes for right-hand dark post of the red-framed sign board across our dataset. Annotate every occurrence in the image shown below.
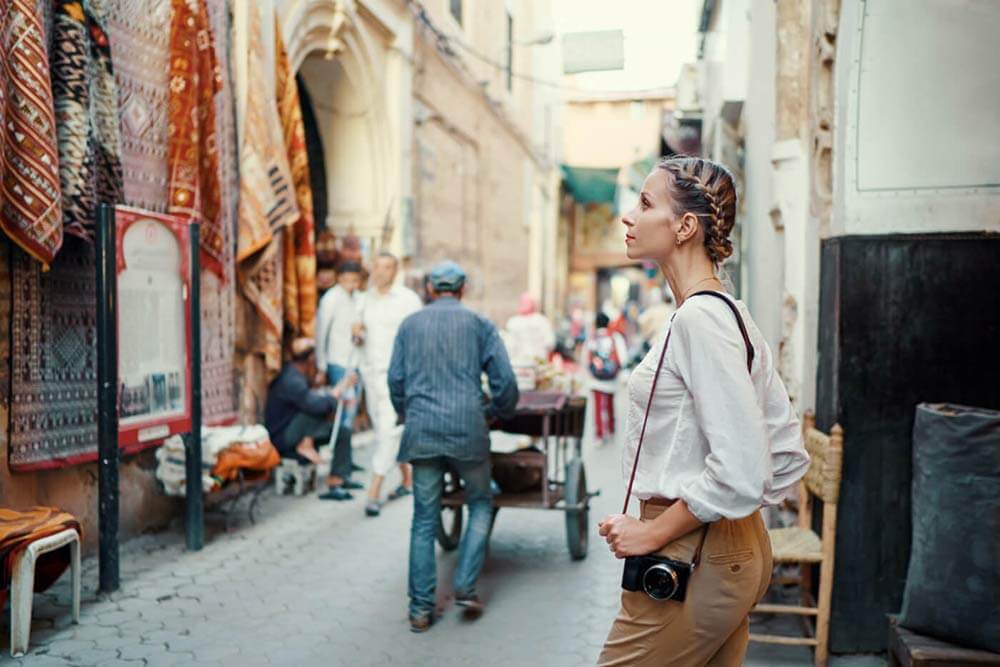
[184,222,205,551]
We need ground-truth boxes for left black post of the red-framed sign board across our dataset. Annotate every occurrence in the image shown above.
[96,204,121,593]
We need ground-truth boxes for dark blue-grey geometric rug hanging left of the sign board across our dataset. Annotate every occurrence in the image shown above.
[9,236,97,470]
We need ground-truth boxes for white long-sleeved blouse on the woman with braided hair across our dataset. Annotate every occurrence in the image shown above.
[622,296,809,523]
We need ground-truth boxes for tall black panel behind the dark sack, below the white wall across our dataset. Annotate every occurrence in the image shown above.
[816,233,1000,653]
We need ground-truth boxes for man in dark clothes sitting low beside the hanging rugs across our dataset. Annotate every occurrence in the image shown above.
[264,338,357,500]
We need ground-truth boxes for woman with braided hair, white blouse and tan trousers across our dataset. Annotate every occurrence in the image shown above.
[599,157,809,667]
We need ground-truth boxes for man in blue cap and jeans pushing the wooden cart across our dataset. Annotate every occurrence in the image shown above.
[389,262,518,632]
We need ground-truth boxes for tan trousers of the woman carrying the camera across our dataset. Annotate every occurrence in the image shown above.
[597,503,771,667]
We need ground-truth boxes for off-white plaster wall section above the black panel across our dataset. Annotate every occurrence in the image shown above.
[831,0,1000,236]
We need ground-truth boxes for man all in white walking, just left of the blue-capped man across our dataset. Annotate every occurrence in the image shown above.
[353,252,423,516]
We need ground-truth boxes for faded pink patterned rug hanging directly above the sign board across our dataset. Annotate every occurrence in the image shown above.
[107,0,170,212]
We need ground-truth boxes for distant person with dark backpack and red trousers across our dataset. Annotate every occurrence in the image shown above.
[583,313,628,445]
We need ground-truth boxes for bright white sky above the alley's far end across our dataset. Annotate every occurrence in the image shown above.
[552,0,704,91]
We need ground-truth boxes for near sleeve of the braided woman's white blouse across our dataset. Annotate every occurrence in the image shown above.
[670,297,771,523]
